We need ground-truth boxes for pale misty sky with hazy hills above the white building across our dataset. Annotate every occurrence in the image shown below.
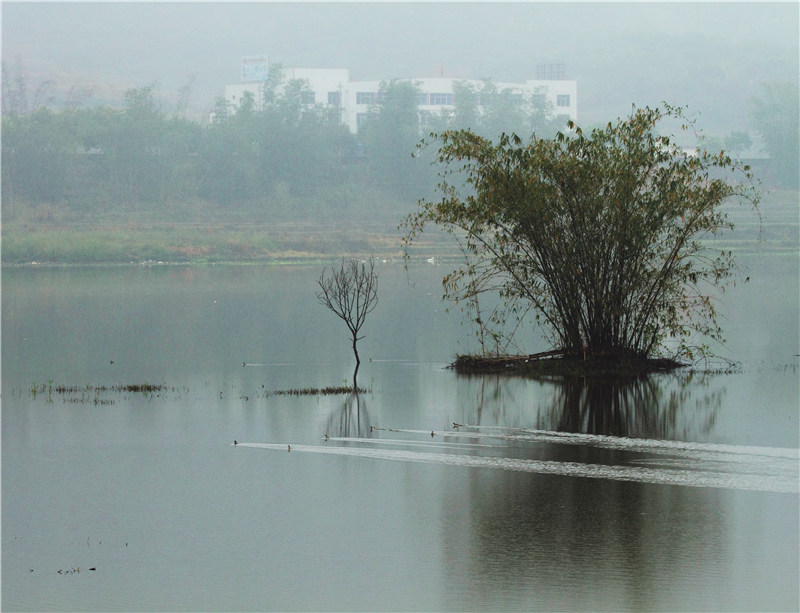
[2,2,800,131]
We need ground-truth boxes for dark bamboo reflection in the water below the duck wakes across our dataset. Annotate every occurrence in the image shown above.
[451,456,793,611]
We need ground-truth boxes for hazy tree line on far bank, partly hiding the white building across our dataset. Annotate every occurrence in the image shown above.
[2,65,563,221]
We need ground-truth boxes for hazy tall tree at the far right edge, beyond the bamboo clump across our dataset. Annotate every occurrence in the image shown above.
[749,82,800,190]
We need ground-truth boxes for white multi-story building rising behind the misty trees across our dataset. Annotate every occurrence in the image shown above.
[225,60,578,133]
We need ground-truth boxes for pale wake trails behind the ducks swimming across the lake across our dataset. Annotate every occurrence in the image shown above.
[238,426,800,494]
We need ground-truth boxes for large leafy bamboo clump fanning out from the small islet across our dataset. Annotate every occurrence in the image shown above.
[404,106,758,359]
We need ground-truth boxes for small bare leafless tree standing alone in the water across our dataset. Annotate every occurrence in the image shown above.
[317,258,378,390]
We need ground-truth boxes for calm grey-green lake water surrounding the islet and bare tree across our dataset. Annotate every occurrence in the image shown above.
[2,255,800,611]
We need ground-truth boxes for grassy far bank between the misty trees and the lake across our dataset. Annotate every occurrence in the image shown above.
[2,191,800,265]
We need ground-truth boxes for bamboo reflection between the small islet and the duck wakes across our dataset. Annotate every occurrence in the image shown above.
[459,372,725,440]
